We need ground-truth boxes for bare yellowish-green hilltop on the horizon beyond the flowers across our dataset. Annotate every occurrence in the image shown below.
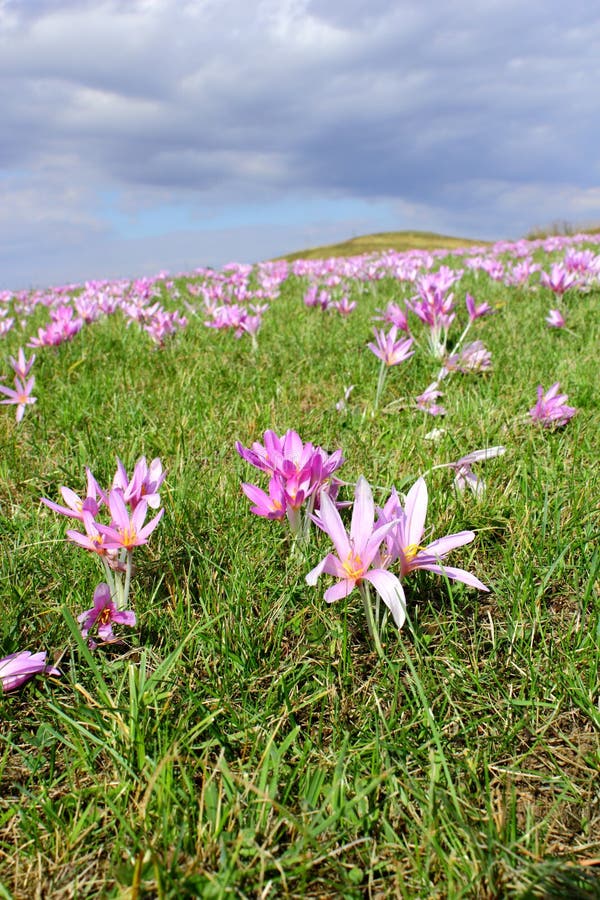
[279,231,492,262]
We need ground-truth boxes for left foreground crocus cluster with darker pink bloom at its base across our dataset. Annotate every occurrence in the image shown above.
[42,456,165,646]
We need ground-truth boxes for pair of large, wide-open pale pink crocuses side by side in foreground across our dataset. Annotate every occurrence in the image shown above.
[306,474,489,651]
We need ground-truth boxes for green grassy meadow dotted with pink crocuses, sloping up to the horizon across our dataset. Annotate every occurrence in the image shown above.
[0,235,600,900]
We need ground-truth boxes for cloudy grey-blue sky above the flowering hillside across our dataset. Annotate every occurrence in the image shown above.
[0,0,600,289]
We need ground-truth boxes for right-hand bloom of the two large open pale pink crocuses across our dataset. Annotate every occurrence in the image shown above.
[378,478,489,591]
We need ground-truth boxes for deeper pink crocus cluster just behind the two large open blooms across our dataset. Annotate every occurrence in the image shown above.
[236,429,344,539]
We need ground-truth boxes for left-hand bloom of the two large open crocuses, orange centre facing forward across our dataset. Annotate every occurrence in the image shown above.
[306,476,406,628]
